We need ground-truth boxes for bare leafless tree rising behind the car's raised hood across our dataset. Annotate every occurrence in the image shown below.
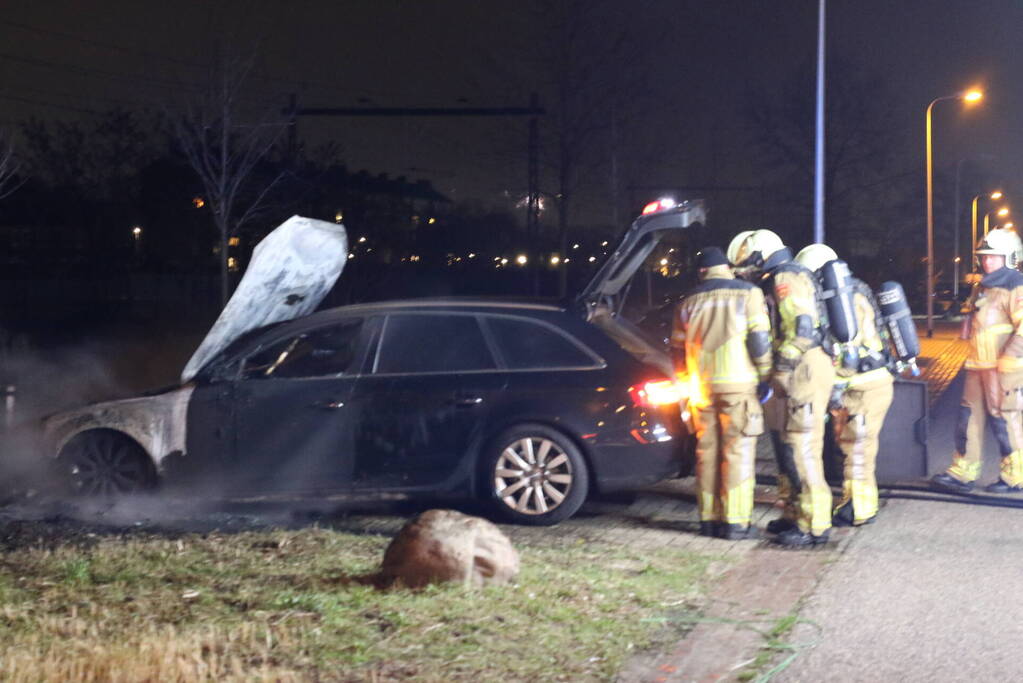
[168,54,287,304]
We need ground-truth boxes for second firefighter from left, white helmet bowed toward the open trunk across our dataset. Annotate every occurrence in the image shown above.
[736,230,835,547]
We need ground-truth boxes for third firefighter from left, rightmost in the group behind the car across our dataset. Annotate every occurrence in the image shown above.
[796,244,894,527]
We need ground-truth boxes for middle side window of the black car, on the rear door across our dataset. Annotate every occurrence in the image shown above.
[375,314,497,374]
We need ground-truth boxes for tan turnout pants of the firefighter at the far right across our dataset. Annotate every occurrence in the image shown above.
[947,369,1023,487]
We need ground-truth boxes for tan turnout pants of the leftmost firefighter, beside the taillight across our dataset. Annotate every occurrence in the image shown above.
[694,390,764,527]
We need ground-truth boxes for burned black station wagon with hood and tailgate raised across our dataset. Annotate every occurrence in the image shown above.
[45,204,703,525]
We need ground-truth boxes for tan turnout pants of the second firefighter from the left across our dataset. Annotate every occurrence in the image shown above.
[767,347,835,536]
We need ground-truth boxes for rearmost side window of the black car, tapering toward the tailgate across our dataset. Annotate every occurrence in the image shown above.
[486,316,597,370]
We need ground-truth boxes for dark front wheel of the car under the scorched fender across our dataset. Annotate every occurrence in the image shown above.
[58,429,158,496]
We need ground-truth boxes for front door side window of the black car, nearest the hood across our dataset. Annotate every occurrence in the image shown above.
[242,319,363,379]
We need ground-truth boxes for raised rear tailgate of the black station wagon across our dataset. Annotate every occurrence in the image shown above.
[578,199,707,315]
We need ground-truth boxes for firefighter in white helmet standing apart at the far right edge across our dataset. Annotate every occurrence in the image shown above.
[931,228,1023,493]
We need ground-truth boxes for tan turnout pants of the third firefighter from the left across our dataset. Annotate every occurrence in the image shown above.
[832,378,894,525]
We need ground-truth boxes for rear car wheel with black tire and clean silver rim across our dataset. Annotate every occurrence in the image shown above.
[484,424,589,527]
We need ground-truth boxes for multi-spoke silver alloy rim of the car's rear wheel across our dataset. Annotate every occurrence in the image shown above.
[494,437,573,515]
